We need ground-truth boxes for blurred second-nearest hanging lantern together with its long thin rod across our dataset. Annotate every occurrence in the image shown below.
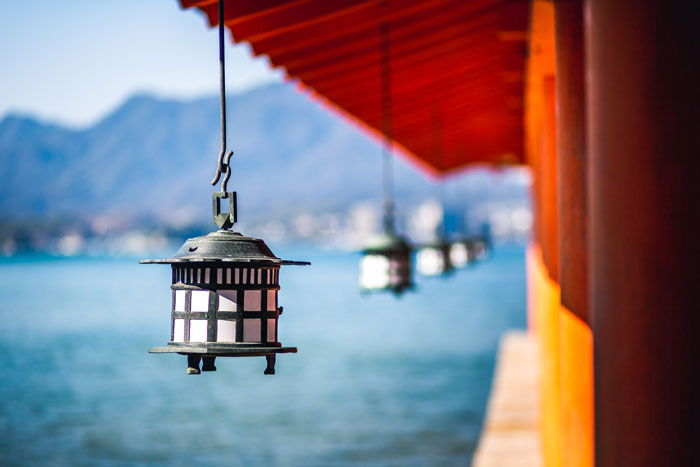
[359,19,413,295]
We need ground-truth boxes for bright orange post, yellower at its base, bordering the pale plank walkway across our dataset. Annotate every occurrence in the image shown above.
[525,0,561,466]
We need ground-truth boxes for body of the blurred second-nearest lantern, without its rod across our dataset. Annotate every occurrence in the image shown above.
[360,233,413,295]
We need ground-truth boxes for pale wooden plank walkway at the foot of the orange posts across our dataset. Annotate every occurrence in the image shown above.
[473,332,543,467]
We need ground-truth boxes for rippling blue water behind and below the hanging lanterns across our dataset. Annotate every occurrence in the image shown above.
[0,247,525,466]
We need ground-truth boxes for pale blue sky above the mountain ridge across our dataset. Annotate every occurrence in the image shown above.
[0,0,281,127]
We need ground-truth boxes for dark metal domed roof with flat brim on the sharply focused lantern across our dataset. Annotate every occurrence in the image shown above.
[140,230,311,266]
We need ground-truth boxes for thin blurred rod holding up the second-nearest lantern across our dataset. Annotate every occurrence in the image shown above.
[380,23,395,234]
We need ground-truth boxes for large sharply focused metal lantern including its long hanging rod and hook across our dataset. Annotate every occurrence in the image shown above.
[141,2,309,375]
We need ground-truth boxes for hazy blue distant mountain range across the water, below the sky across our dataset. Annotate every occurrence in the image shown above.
[0,84,525,232]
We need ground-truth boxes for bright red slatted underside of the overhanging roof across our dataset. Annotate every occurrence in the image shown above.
[180,0,529,174]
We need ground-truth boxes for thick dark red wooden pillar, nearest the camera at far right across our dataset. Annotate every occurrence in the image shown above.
[585,0,700,467]
